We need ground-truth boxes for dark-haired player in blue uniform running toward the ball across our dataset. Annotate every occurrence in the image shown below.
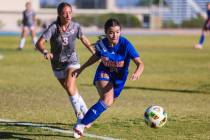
[73,19,144,138]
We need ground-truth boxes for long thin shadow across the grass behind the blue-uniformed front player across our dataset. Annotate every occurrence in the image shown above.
[81,84,210,94]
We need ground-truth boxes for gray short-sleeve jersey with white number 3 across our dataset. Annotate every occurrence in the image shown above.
[42,22,83,70]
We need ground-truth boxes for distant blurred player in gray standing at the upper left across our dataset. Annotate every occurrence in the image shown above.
[18,2,37,50]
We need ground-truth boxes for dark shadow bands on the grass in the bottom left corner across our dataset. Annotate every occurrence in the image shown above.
[0,121,73,140]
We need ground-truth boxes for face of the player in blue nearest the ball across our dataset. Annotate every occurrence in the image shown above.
[106,26,121,45]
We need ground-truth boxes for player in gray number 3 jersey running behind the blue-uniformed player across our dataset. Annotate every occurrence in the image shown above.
[36,2,94,135]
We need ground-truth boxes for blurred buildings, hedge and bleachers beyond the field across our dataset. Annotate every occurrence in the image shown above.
[0,0,210,34]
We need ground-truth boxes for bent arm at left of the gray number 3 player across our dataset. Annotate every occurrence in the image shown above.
[36,36,53,59]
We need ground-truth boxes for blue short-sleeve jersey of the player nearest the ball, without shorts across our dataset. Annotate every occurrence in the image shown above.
[96,37,139,72]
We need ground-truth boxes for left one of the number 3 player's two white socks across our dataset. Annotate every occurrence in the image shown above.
[69,94,84,120]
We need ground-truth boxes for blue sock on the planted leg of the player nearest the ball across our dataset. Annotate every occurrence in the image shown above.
[81,100,107,125]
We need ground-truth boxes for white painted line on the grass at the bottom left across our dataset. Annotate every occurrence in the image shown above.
[0,119,119,140]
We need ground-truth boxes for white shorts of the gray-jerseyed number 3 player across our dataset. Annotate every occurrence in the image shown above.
[53,64,80,79]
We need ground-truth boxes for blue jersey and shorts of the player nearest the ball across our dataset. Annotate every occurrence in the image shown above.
[94,36,139,96]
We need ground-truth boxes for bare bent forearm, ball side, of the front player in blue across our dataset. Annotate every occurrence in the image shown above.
[130,57,144,81]
